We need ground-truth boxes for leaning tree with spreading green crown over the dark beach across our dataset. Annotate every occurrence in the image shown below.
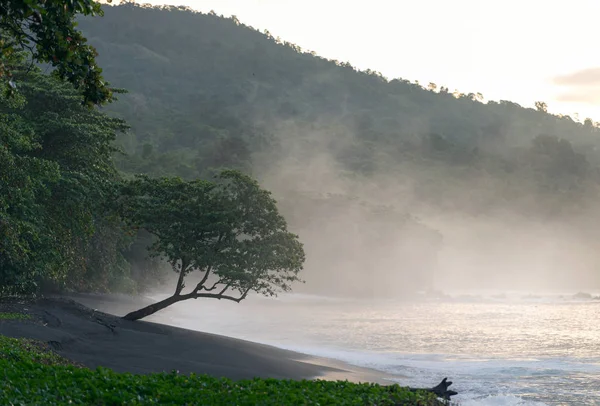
[117,170,304,320]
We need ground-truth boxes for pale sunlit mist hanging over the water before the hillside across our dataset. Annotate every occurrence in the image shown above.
[246,121,600,297]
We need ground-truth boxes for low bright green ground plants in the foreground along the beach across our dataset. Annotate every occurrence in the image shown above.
[0,336,438,406]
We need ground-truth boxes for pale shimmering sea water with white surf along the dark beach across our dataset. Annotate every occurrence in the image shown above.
[149,292,600,406]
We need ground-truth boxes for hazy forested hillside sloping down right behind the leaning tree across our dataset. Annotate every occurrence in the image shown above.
[75,4,600,292]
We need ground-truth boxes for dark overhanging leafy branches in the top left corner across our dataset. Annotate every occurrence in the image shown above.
[0,0,112,105]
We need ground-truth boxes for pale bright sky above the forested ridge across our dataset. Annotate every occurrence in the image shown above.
[113,0,600,121]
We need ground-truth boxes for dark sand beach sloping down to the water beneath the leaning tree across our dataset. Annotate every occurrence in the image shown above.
[0,295,398,383]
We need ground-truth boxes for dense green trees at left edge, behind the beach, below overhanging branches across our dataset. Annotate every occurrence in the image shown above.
[0,59,126,294]
